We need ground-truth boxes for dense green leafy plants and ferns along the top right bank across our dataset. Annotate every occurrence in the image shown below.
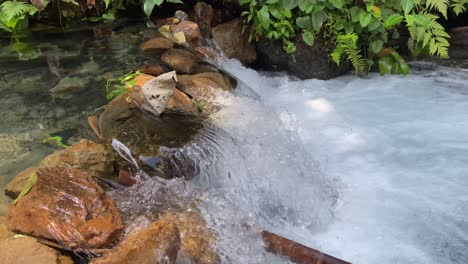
[240,0,468,74]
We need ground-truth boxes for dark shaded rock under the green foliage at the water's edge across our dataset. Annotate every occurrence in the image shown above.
[256,40,350,80]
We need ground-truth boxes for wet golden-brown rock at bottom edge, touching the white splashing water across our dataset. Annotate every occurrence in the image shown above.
[161,211,218,264]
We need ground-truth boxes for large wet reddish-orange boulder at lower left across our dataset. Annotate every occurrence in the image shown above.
[8,167,123,251]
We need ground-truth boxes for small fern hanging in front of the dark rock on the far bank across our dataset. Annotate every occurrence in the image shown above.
[331,33,366,75]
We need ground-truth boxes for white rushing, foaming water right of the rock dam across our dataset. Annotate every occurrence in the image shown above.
[187,61,468,264]
